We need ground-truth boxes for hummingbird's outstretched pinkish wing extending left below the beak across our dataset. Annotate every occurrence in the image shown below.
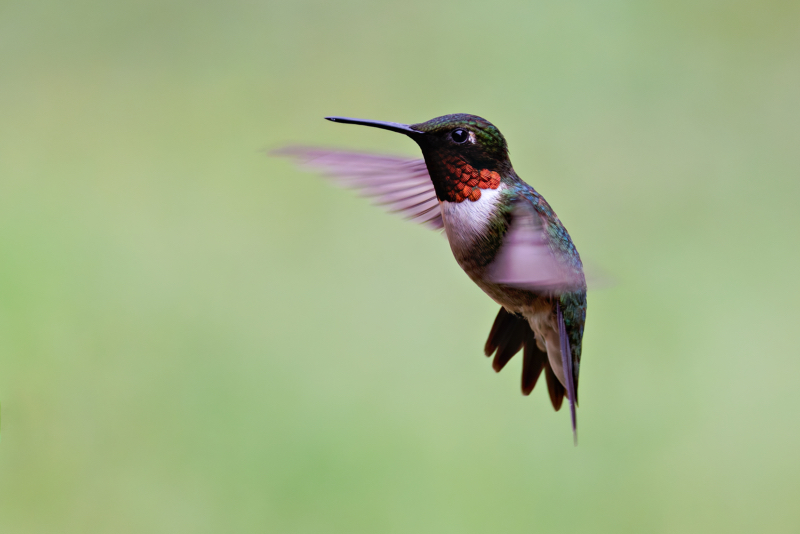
[272,146,444,229]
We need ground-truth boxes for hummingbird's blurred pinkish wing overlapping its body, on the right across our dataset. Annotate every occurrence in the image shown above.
[488,201,585,293]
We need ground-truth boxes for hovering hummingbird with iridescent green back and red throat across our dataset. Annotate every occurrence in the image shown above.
[278,113,586,444]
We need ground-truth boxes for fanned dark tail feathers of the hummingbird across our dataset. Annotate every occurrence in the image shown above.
[483,308,567,411]
